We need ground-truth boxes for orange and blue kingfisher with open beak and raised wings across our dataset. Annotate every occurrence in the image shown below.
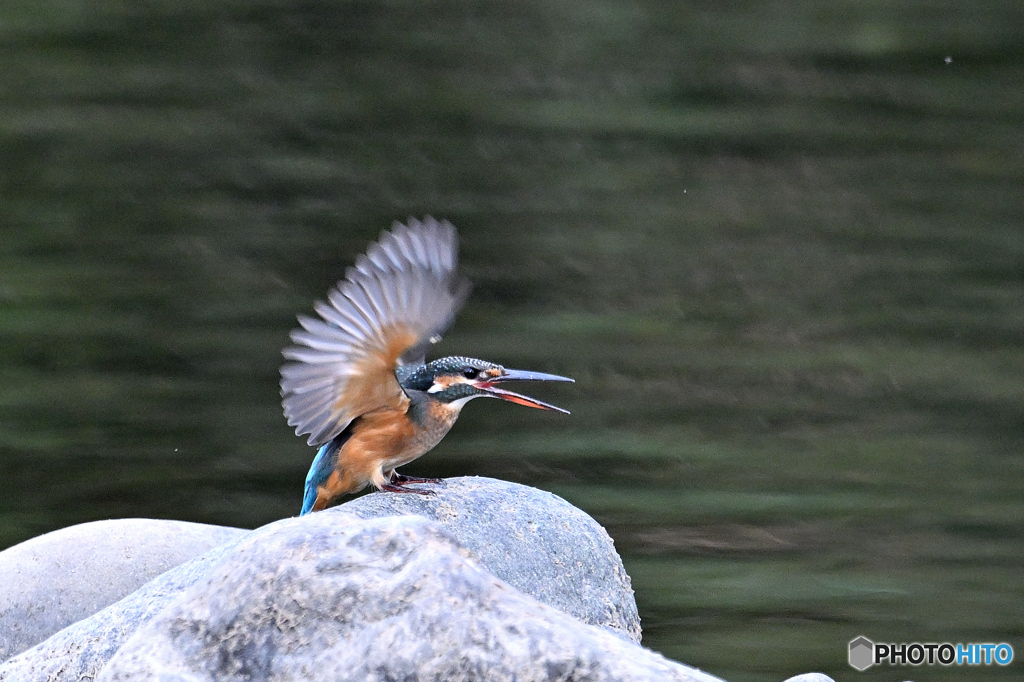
[281,216,573,516]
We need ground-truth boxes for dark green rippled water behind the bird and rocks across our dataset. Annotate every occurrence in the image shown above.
[0,0,1024,681]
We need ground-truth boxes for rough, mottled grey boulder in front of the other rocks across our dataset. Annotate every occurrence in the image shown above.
[97,509,718,682]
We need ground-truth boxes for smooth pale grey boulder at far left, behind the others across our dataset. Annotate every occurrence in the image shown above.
[0,519,247,660]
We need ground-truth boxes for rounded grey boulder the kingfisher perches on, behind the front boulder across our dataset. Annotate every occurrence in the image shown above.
[0,477,640,682]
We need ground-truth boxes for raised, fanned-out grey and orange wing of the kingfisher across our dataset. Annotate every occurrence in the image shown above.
[281,217,469,445]
